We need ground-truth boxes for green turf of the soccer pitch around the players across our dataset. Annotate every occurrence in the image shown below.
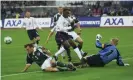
[1,28,133,80]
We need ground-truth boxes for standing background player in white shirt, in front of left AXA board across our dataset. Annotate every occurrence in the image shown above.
[23,11,41,46]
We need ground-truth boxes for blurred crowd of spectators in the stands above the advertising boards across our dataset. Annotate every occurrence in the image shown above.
[1,1,133,19]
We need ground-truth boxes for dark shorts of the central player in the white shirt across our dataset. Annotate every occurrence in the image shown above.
[55,32,72,46]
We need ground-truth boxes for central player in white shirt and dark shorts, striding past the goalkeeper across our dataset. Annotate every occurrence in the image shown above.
[46,8,82,59]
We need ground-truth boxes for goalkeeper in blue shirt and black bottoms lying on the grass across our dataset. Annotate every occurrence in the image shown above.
[74,34,129,67]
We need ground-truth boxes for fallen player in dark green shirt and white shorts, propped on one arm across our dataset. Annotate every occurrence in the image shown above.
[22,44,76,72]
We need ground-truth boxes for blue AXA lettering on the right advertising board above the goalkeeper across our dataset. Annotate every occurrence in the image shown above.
[104,18,124,25]
